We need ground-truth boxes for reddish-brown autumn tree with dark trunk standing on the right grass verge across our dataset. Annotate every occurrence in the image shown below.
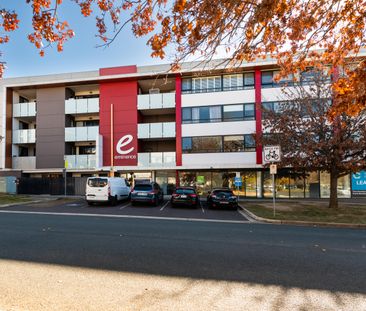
[261,69,366,208]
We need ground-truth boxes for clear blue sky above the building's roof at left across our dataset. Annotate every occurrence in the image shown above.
[0,0,171,78]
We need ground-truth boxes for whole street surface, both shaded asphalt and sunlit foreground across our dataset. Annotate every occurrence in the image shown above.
[0,203,366,310]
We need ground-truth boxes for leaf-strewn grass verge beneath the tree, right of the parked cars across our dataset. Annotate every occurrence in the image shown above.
[243,202,366,224]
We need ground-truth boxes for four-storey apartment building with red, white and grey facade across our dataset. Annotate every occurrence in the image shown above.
[0,59,358,198]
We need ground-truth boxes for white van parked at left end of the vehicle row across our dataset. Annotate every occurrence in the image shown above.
[85,177,130,205]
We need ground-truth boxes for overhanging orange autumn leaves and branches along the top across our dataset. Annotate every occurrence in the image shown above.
[0,0,366,114]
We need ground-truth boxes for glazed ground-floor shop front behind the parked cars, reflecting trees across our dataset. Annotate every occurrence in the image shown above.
[92,169,351,198]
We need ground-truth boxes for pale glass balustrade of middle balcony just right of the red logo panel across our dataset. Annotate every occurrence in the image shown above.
[137,122,175,139]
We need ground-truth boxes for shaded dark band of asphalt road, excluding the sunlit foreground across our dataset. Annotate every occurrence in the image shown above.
[0,213,366,294]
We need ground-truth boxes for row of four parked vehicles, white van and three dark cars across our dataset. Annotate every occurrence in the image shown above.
[85,177,238,209]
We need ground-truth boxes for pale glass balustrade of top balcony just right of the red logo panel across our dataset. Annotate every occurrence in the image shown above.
[137,93,175,110]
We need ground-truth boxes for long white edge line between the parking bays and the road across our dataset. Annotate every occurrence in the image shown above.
[0,210,249,224]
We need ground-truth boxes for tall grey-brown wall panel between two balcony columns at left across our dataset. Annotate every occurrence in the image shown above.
[36,87,65,168]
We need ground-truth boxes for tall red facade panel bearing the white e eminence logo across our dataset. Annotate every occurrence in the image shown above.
[99,81,138,166]
